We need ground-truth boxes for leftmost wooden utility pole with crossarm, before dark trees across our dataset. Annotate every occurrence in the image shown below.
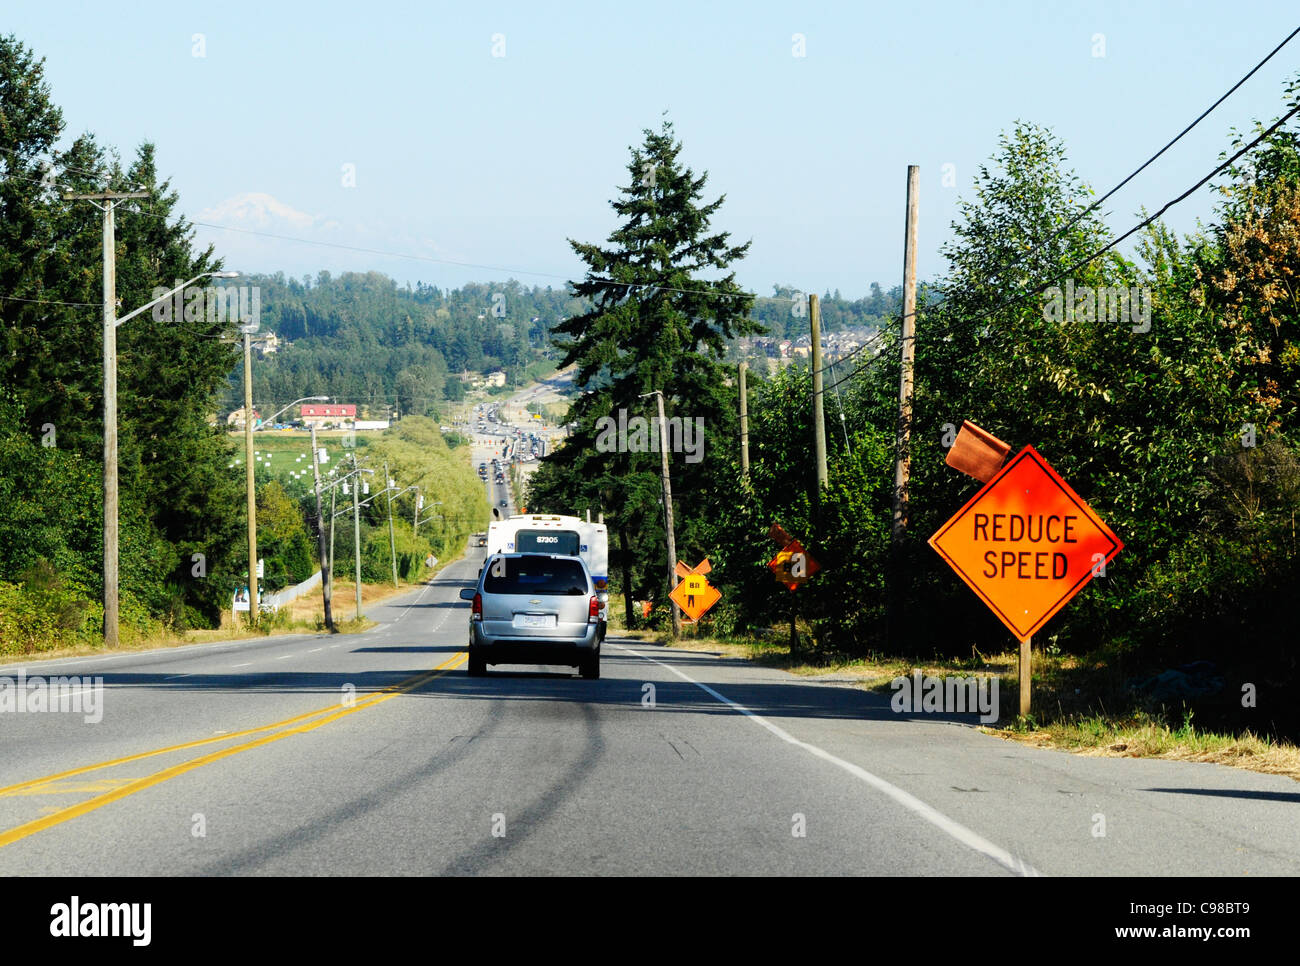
[64,191,150,647]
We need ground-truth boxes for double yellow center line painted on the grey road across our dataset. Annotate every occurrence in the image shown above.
[0,651,468,848]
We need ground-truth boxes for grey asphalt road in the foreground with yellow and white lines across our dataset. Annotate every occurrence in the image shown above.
[0,550,1300,875]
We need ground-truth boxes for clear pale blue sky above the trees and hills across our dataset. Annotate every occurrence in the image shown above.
[10,0,1300,295]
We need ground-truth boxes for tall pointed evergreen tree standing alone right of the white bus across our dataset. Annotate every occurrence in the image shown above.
[529,122,762,624]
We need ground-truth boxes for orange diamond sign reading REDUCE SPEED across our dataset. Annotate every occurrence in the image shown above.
[930,446,1123,642]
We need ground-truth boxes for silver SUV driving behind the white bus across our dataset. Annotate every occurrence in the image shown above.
[460,554,601,679]
